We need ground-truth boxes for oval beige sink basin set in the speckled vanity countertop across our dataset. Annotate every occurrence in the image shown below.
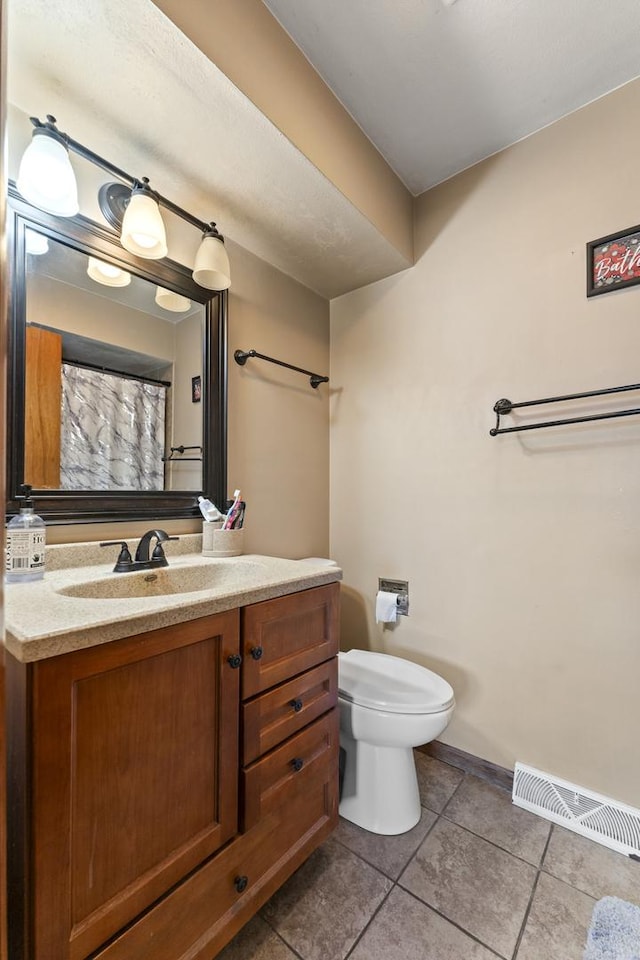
[56,560,261,600]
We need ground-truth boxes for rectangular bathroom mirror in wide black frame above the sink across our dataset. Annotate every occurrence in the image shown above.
[7,189,226,523]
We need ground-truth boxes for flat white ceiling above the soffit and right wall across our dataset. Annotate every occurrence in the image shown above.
[263,0,640,194]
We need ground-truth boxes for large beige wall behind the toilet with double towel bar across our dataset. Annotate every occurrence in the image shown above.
[331,82,640,806]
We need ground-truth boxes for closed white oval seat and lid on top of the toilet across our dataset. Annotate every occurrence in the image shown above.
[338,650,454,714]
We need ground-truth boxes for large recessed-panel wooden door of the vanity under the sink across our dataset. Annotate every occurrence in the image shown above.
[33,611,239,960]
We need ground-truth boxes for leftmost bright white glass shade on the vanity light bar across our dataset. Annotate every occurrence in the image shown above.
[16,130,80,217]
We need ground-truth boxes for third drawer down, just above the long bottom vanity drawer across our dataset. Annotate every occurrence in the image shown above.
[241,709,338,830]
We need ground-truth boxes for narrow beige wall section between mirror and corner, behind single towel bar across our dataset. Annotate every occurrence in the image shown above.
[228,235,331,558]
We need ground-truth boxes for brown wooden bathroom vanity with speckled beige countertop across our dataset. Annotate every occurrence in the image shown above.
[7,548,341,960]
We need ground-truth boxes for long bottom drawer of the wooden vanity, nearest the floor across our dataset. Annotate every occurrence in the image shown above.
[95,711,338,960]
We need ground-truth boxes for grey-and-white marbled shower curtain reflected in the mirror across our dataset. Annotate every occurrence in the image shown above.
[60,363,167,490]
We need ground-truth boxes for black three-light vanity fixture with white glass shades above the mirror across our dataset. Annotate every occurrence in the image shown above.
[17,114,231,290]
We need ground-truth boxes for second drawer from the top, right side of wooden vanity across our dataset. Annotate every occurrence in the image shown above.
[242,657,338,766]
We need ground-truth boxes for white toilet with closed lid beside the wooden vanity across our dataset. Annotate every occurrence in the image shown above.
[338,650,455,835]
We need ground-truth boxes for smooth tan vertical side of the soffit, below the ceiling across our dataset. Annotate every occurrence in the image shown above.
[149,0,413,261]
